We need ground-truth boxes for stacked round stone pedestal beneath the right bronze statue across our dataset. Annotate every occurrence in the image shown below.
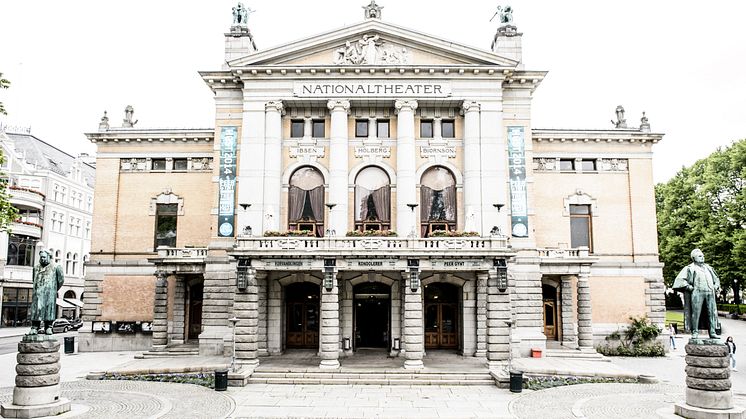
[674,339,746,419]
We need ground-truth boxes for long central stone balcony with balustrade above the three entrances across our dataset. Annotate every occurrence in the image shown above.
[234,237,511,258]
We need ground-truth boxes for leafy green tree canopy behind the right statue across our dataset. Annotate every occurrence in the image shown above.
[655,139,746,303]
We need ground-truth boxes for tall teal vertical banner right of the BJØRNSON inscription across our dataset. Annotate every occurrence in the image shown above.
[508,127,528,237]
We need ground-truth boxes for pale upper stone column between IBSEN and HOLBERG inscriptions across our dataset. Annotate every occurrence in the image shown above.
[326,100,350,236]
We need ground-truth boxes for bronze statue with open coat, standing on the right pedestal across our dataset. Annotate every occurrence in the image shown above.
[673,249,720,339]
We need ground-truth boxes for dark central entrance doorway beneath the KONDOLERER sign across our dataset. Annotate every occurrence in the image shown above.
[354,282,391,349]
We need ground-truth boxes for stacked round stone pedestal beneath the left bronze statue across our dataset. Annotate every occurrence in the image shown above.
[0,335,70,418]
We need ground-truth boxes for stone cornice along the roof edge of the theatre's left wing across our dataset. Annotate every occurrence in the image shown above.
[85,128,215,143]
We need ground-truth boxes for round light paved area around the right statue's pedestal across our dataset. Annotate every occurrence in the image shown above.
[510,384,746,419]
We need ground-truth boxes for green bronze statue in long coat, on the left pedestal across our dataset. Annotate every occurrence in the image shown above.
[29,250,65,335]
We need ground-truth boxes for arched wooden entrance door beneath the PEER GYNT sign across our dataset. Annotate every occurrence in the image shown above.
[425,283,460,349]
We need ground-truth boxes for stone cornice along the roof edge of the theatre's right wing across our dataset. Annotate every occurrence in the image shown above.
[531,128,664,144]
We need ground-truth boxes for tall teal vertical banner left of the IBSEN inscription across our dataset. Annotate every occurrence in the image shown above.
[218,127,238,237]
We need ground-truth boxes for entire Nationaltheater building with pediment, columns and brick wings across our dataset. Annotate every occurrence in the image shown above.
[80,2,664,368]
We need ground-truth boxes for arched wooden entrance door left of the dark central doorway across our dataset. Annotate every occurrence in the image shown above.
[285,282,319,349]
